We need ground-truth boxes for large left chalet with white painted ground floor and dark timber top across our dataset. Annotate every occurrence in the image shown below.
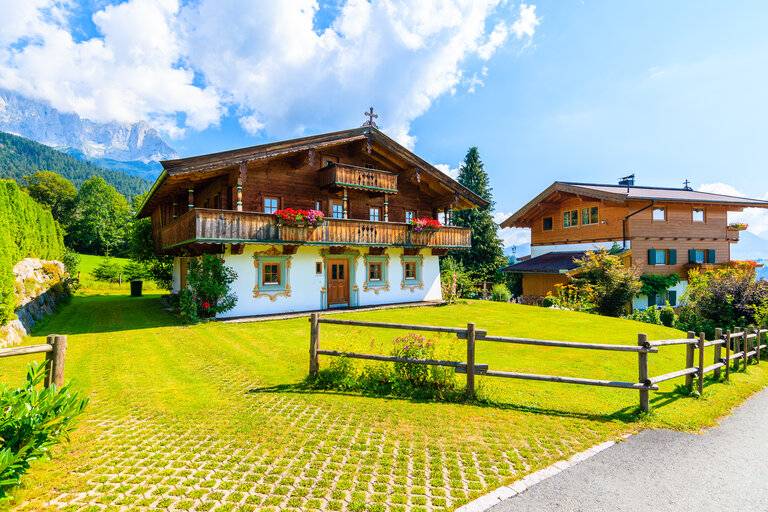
[138,121,486,316]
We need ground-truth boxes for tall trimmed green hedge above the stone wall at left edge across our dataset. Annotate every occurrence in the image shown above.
[0,180,64,325]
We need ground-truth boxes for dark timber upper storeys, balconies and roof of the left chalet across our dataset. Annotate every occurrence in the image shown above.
[139,127,485,254]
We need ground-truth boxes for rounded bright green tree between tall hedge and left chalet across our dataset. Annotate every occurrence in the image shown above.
[67,176,132,256]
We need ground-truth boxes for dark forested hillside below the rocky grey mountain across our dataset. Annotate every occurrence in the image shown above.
[0,132,150,197]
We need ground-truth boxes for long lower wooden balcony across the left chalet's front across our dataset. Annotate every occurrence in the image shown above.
[160,208,471,250]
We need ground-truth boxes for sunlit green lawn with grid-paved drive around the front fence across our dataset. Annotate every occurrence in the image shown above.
[0,290,768,511]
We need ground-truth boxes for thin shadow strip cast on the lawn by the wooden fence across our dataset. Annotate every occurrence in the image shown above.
[246,382,640,423]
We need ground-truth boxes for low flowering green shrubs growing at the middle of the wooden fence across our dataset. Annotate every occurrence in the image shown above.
[308,333,464,401]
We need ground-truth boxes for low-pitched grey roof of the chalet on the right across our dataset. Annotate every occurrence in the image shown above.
[501,181,768,228]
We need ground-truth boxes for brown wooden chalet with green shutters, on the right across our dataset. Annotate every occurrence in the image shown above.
[501,177,768,308]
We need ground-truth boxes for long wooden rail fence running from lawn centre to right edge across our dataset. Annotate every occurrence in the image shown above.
[309,313,768,412]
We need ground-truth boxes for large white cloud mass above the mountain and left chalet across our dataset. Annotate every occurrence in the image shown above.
[0,0,539,141]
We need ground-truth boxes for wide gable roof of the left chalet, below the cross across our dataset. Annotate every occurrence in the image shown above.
[137,126,488,217]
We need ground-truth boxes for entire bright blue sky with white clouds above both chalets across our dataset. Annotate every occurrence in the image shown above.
[0,0,768,241]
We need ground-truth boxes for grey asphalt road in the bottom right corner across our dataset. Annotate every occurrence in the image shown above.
[490,389,768,512]
